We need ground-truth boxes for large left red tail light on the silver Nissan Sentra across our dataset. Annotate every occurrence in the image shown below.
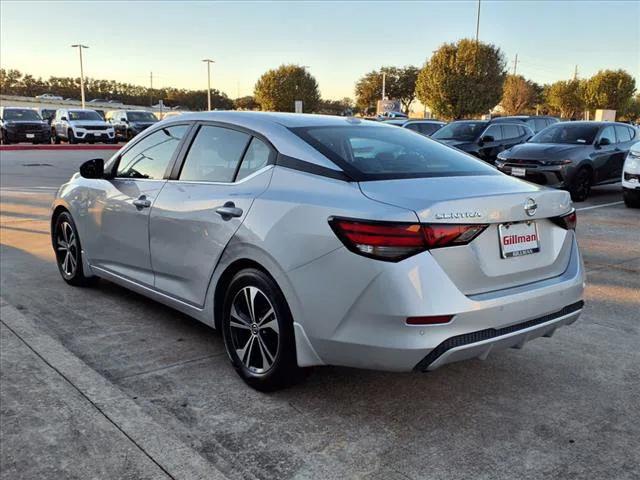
[329,217,488,262]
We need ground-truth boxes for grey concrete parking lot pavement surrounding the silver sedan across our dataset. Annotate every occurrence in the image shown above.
[0,151,640,480]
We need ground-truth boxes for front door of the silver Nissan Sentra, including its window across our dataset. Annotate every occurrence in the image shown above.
[87,124,190,286]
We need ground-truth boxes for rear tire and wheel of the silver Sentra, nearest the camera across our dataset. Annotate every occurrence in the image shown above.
[221,268,304,392]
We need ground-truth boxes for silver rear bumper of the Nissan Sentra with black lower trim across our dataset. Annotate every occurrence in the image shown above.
[290,232,584,371]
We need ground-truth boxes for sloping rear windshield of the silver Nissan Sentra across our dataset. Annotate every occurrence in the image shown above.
[291,125,499,180]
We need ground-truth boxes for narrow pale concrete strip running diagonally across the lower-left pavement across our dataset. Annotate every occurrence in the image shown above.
[0,297,228,480]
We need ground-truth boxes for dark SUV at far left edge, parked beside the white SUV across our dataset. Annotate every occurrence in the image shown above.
[0,107,50,145]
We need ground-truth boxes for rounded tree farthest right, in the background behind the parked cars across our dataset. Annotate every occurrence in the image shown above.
[583,70,636,113]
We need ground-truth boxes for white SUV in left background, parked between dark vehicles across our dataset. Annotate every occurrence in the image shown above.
[51,108,116,143]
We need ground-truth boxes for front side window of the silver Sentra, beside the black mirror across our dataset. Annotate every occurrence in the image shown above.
[116,125,189,180]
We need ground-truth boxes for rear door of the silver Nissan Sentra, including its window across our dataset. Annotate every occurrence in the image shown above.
[150,124,275,306]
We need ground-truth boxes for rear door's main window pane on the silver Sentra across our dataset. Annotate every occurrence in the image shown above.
[180,125,251,183]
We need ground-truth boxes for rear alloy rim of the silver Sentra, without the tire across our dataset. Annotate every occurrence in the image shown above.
[229,286,280,374]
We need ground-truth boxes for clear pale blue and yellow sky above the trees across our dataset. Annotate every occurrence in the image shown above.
[0,0,640,99]
